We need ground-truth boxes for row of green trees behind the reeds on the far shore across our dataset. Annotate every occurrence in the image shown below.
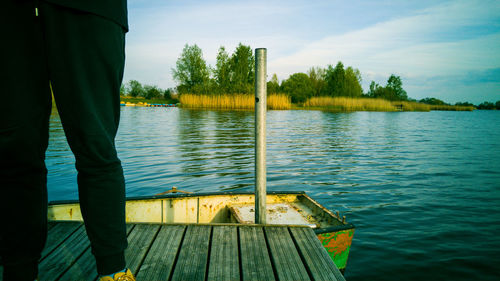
[172,43,408,103]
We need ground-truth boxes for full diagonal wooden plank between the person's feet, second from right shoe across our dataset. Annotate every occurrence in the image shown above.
[39,226,90,280]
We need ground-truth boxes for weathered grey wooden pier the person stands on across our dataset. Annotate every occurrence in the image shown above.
[0,222,345,281]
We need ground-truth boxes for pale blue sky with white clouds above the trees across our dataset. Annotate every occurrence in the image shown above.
[124,0,500,104]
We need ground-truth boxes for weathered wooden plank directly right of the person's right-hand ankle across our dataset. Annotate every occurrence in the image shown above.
[125,224,160,274]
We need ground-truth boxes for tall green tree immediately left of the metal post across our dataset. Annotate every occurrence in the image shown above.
[231,43,255,94]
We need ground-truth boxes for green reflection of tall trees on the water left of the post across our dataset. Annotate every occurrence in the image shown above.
[178,109,253,190]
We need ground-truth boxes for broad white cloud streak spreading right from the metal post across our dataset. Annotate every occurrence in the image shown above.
[270,1,500,76]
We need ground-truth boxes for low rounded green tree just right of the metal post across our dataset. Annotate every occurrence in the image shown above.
[281,73,314,103]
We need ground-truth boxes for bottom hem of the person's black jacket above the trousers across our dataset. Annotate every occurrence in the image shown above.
[43,0,128,31]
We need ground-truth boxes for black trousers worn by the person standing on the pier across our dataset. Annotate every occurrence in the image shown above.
[0,0,127,280]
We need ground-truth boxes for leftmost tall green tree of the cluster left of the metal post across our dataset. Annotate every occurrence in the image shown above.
[172,44,210,93]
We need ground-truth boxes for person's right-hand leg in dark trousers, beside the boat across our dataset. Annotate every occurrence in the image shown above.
[40,1,127,275]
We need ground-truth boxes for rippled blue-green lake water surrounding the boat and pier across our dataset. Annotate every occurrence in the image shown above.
[46,107,500,280]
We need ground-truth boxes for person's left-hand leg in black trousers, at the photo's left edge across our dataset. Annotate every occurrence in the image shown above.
[0,0,52,281]
